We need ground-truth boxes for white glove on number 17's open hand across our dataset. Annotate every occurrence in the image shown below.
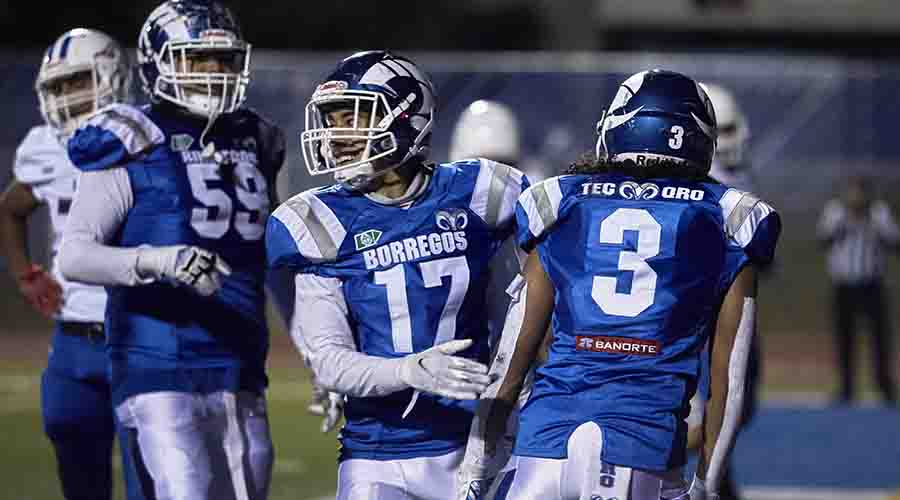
[397,339,491,399]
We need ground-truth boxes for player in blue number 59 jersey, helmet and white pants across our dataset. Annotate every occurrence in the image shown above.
[60,0,284,499]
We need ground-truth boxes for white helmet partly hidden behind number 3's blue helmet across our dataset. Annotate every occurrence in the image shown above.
[700,83,750,169]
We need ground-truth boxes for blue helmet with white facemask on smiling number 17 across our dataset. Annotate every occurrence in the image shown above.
[300,51,436,189]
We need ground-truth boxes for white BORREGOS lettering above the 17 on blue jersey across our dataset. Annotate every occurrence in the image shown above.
[363,231,469,270]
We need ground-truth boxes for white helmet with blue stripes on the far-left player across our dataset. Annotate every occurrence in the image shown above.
[34,28,131,140]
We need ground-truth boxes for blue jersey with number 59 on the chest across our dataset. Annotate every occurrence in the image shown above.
[69,104,284,401]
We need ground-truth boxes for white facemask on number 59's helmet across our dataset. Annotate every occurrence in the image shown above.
[153,30,250,118]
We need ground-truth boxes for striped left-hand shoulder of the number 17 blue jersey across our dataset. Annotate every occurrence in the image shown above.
[266,189,347,267]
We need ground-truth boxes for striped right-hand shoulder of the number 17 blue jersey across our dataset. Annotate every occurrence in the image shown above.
[468,158,530,228]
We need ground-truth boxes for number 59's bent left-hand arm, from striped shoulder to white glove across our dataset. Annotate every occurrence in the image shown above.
[59,105,230,295]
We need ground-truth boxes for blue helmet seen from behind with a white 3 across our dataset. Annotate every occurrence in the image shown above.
[596,69,716,173]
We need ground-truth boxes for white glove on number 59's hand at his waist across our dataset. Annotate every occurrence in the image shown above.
[135,245,231,296]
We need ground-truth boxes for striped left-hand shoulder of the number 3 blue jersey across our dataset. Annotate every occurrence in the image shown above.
[516,177,563,248]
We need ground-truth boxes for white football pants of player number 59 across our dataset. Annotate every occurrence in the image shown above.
[116,391,274,500]
